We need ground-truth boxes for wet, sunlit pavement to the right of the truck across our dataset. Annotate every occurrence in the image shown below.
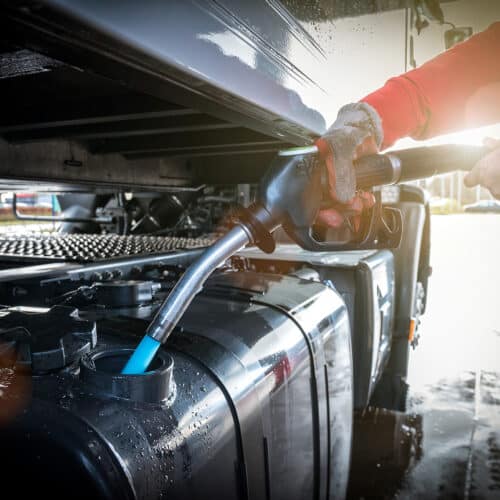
[350,215,500,499]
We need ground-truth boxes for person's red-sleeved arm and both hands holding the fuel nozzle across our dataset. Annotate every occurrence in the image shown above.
[317,22,500,227]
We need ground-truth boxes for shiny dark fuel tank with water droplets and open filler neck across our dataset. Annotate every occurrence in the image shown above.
[0,272,352,499]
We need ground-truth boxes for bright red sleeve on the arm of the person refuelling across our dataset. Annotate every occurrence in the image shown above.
[362,22,500,148]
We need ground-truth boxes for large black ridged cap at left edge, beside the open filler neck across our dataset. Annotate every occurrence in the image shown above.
[0,305,97,374]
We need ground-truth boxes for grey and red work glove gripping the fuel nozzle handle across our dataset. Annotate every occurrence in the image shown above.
[316,102,383,230]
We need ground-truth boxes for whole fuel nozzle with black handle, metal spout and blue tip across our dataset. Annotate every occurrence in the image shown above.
[122,145,485,375]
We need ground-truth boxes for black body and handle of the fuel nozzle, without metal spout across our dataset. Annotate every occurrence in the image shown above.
[259,145,487,252]
